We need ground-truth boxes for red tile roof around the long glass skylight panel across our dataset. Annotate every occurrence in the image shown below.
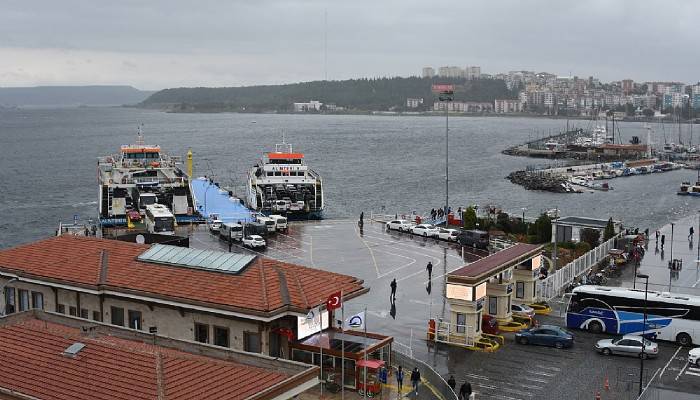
[0,235,367,316]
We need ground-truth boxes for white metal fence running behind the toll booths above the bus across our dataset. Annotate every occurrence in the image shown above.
[536,236,618,301]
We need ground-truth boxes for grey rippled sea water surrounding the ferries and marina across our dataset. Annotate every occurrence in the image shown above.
[0,108,700,248]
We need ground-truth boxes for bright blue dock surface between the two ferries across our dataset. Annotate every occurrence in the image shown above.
[190,178,254,222]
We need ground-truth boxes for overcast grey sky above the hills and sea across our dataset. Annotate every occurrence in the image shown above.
[0,0,700,89]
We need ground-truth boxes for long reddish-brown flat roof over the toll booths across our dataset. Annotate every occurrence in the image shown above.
[448,243,542,283]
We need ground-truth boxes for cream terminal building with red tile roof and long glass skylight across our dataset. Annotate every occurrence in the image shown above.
[0,235,368,357]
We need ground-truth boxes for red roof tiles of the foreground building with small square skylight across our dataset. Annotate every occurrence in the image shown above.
[0,318,303,400]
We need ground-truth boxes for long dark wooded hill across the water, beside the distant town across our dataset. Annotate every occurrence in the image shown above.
[140,77,516,112]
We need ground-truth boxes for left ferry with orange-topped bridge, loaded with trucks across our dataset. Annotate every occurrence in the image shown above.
[97,129,194,227]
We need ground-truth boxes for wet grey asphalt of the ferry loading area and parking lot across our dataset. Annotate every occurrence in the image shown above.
[190,221,700,400]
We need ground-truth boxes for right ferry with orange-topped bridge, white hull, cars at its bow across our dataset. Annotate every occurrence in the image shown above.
[246,142,323,219]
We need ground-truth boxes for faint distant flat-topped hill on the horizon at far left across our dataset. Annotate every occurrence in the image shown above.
[0,86,153,107]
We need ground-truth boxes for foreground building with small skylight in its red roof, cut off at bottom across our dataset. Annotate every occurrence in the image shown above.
[0,310,319,400]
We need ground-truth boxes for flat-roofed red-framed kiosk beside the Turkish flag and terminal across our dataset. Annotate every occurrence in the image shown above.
[290,329,394,389]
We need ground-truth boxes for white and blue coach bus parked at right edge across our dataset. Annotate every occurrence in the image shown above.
[566,285,700,346]
